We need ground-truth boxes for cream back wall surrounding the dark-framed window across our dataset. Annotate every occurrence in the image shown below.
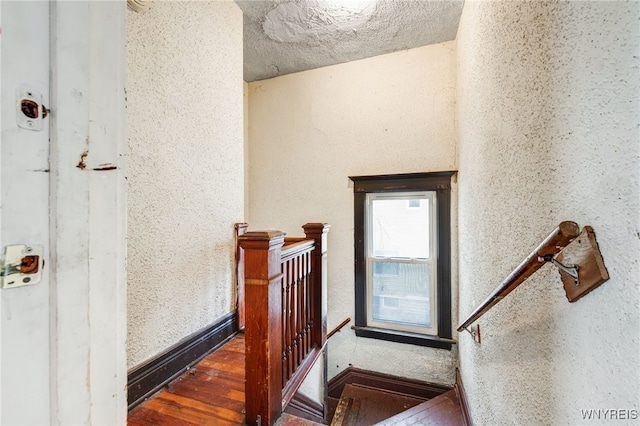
[249,42,456,382]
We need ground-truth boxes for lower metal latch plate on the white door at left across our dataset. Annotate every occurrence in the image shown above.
[0,244,44,288]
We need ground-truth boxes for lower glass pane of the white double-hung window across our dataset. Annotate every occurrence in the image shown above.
[372,261,432,327]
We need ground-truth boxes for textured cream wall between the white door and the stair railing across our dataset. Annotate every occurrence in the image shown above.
[127,1,244,367]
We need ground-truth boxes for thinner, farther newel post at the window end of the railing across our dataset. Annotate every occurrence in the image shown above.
[302,223,331,348]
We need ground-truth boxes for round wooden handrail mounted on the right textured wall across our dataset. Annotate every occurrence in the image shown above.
[457,221,580,334]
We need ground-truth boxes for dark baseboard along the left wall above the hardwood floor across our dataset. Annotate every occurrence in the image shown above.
[127,311,238,410]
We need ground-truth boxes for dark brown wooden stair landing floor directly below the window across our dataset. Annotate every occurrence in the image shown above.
[331,384,424,426]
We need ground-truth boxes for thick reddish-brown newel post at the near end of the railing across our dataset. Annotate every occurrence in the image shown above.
[238,231,284,425]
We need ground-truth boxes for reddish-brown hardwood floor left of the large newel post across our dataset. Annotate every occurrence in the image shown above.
[127,334,245,426]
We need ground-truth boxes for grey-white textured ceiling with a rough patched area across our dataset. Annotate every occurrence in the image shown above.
[236,0,464,82]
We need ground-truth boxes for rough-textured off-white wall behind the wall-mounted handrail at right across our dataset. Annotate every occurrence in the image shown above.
[457,1,640,425]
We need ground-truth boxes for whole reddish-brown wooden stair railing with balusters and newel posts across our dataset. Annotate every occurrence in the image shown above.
[238,223,329,425]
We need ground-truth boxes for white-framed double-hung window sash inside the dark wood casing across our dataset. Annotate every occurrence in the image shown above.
[364,191,438,334]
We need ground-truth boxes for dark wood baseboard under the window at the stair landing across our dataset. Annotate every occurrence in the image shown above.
[328,367,451,401]
